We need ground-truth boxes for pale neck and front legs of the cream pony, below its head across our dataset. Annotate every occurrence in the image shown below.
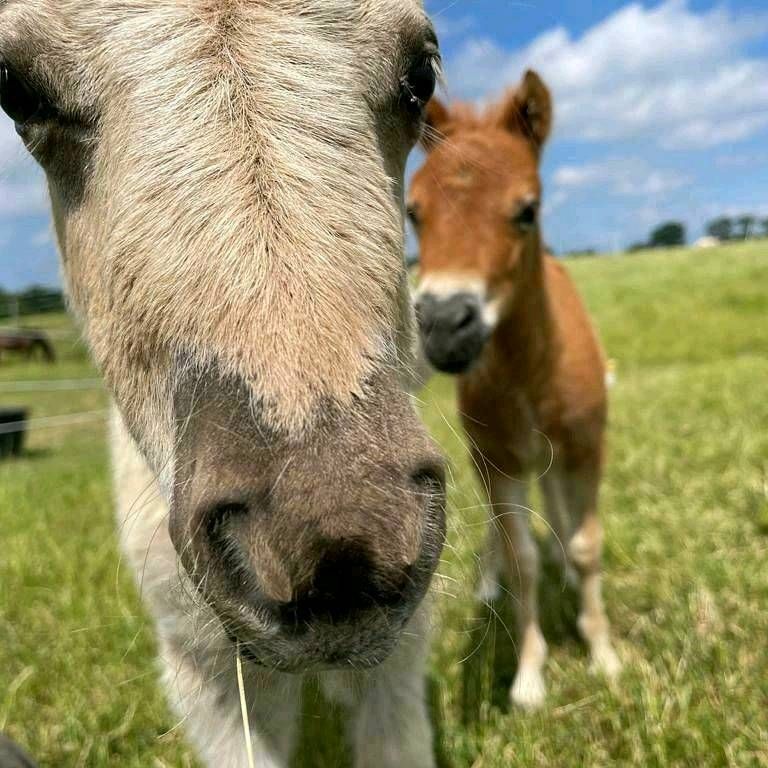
[111,410,434,768]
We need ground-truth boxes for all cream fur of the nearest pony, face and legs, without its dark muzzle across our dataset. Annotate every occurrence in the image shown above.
[0,0,444,768]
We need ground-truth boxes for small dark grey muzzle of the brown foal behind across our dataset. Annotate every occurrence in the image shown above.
[416,292,490,374]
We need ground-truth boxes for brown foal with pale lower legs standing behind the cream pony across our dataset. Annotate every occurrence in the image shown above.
[409,72,620,708]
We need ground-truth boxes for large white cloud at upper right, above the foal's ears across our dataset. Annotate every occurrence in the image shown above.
[448,0,768,148]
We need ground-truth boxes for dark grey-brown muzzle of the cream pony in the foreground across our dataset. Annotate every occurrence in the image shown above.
[170,368,445,669]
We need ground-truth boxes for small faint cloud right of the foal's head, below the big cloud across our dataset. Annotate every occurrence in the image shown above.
[552,158,691,196]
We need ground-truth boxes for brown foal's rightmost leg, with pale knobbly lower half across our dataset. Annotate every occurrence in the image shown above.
[566,468,621,678]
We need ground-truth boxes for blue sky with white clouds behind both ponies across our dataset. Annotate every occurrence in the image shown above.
[0,0,768,288]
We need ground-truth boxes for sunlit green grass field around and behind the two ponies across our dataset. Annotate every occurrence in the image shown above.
[0,243,768,768]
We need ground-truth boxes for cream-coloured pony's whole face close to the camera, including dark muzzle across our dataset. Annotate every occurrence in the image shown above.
[0,0,442,666]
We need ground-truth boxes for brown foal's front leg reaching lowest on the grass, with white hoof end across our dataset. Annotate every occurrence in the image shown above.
[488,471,547,709]
